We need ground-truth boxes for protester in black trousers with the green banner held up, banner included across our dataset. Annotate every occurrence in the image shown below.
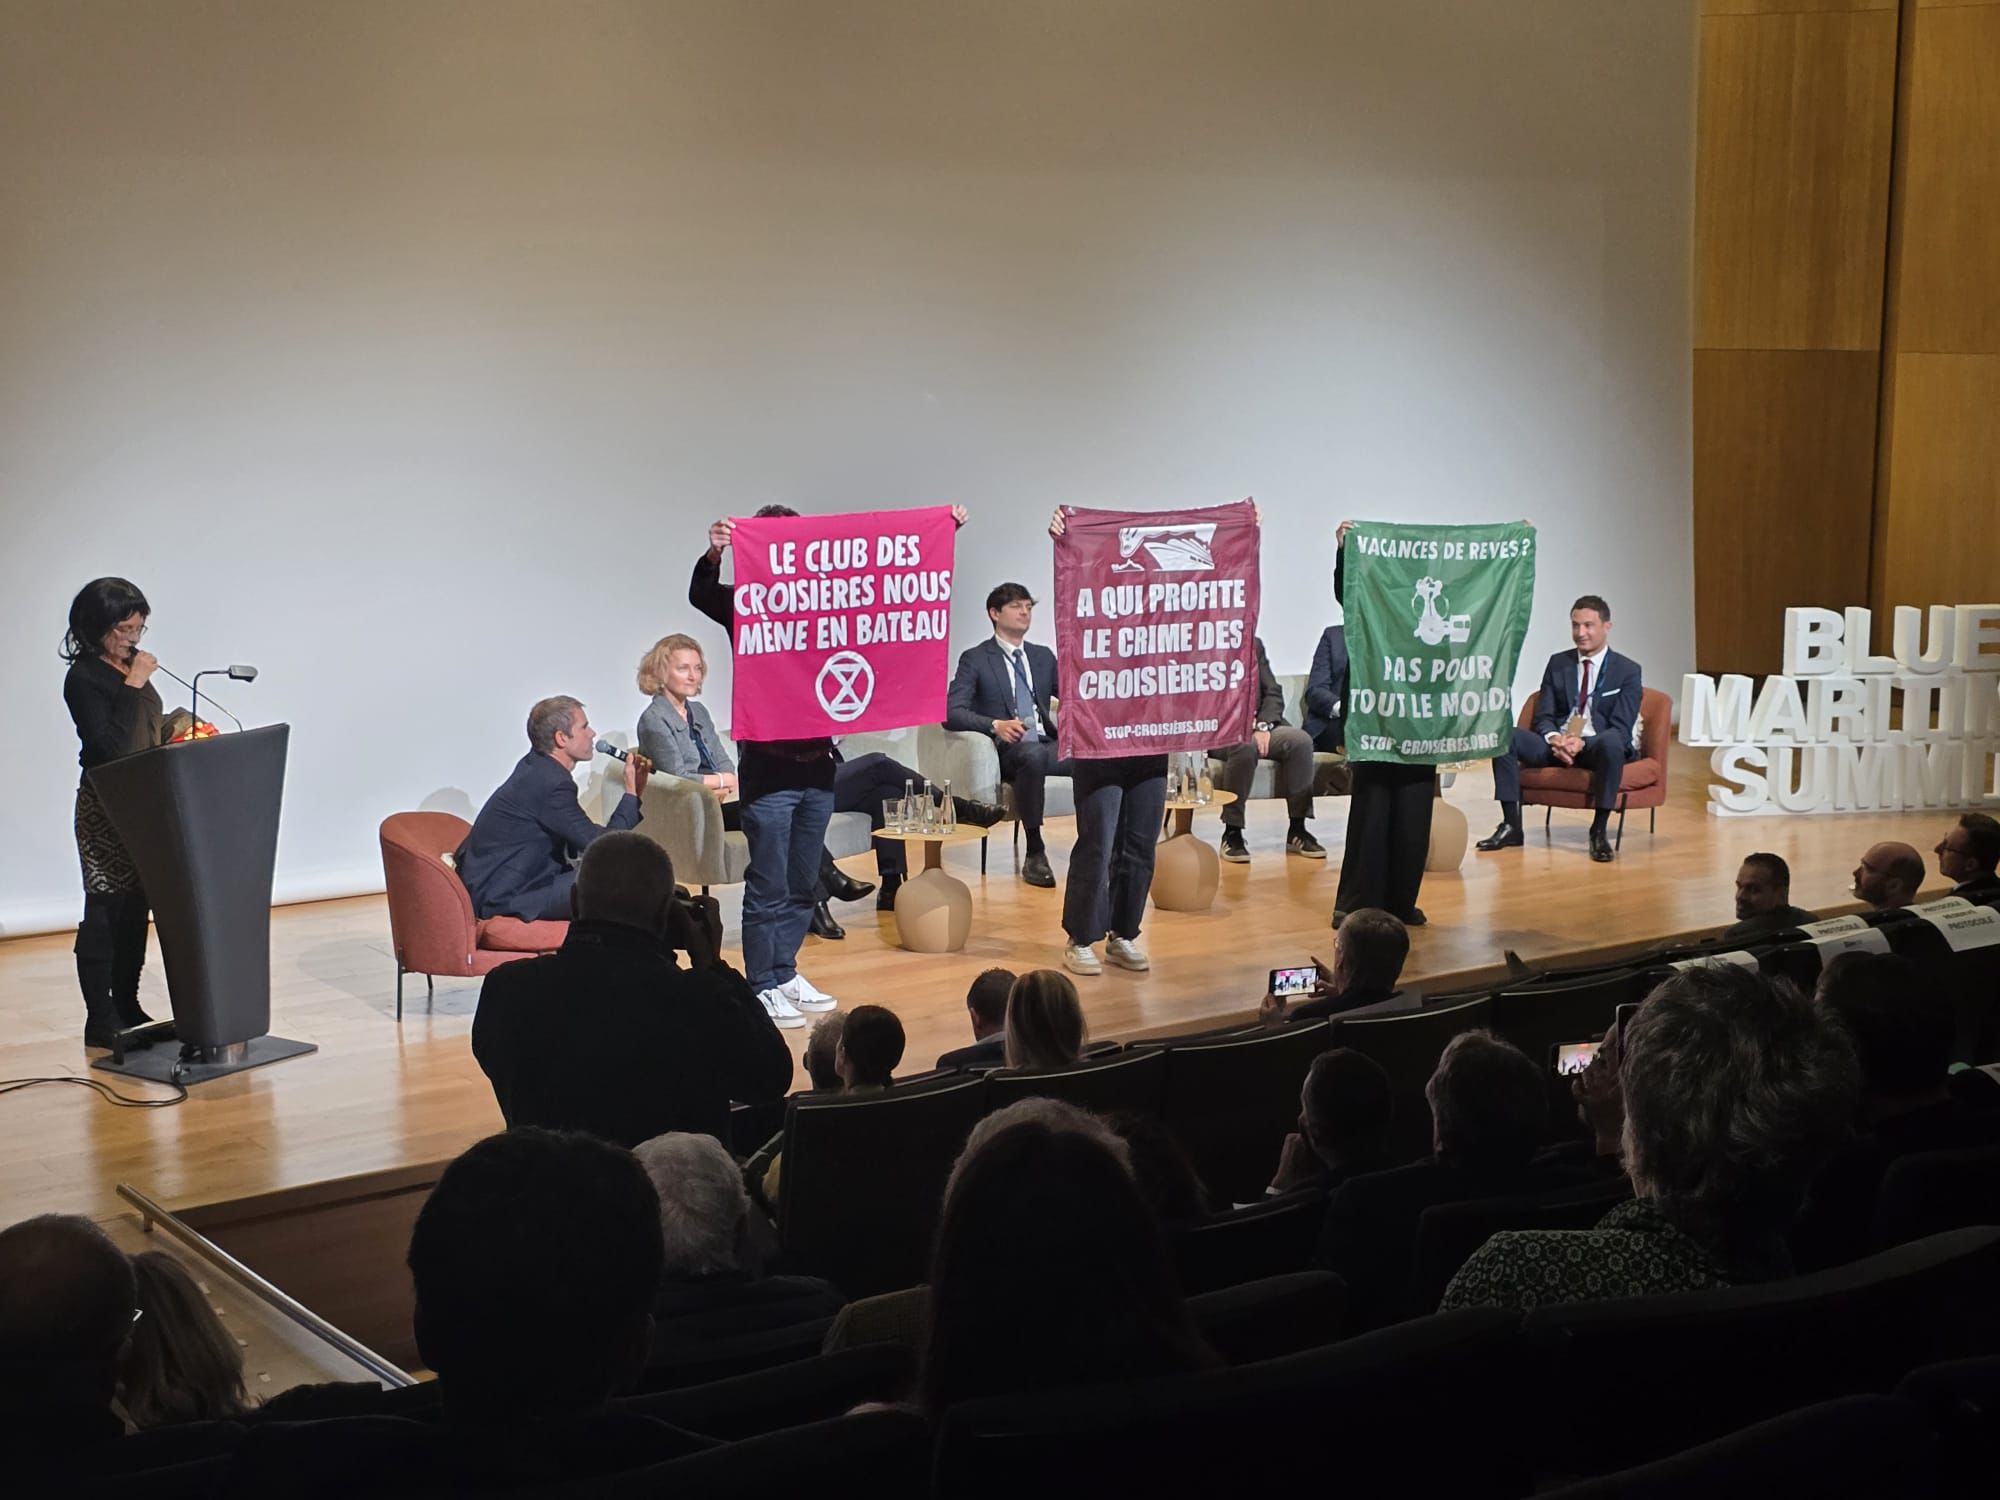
[1334,520,1534,928]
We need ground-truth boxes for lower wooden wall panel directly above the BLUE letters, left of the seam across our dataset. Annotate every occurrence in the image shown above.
[1694,350,1880,674]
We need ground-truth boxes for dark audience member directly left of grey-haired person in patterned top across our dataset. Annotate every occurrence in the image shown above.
[1314,1032,1590,1328]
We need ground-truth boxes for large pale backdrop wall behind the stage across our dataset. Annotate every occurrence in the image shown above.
[0,0,1694,934]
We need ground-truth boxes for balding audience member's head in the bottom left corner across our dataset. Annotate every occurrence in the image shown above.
[0,1214,138,1472]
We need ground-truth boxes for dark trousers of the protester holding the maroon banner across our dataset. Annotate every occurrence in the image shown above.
[1062,756,1166,946]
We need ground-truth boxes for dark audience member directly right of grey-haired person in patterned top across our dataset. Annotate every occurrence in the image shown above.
[1792,954,2000,1270]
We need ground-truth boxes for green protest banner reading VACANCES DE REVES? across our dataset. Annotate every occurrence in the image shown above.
[1340,522,1534,766]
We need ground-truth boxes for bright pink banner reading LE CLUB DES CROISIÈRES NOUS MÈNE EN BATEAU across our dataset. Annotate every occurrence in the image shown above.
[730,506,956,740]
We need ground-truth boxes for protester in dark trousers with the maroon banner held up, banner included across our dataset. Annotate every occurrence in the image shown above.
[1048,500,1258,974]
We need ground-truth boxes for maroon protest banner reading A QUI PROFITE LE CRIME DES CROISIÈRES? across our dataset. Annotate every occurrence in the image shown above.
[1056,500,1260,760]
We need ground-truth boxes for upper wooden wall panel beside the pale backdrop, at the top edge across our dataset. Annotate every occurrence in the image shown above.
[1694,10,1896,350]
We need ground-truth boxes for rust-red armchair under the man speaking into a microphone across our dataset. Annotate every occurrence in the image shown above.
[380,812,570,1020]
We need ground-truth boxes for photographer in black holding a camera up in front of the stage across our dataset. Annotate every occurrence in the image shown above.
[472,832,794,1148]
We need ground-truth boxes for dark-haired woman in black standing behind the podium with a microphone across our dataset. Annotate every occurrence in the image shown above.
[62,578,162,1046]
